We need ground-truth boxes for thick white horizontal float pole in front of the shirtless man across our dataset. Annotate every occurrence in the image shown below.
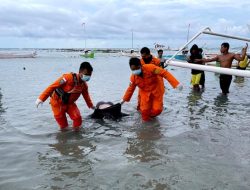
[166,61,250,78]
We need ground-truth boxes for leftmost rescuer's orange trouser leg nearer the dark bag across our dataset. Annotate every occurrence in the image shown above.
[67,103,82,128]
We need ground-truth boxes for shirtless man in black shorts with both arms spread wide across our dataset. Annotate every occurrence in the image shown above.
[195,42,248,95]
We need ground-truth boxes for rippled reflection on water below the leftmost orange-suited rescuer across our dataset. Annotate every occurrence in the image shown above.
[38,131,96,189]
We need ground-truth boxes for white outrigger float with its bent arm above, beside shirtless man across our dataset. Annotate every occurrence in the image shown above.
[165,27,250,78]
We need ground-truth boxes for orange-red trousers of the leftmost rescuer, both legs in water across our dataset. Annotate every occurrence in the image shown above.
[51,103,82,129]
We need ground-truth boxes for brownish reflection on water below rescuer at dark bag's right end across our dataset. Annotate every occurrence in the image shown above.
[125,119,163,162]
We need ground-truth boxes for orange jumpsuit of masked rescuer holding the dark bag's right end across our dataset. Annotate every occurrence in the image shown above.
[123,64,179,121]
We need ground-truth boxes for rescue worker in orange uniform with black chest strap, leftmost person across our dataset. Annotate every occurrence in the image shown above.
[36,62,95,130]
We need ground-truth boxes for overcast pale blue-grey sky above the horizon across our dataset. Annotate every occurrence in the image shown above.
[0,0,250,48]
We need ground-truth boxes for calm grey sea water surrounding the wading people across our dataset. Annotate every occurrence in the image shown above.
[0,51,250,190]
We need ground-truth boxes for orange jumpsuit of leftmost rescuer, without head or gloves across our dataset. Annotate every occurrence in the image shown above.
[39,73,93,129]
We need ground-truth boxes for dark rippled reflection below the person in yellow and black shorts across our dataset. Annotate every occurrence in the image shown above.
[187,91,208,129]
